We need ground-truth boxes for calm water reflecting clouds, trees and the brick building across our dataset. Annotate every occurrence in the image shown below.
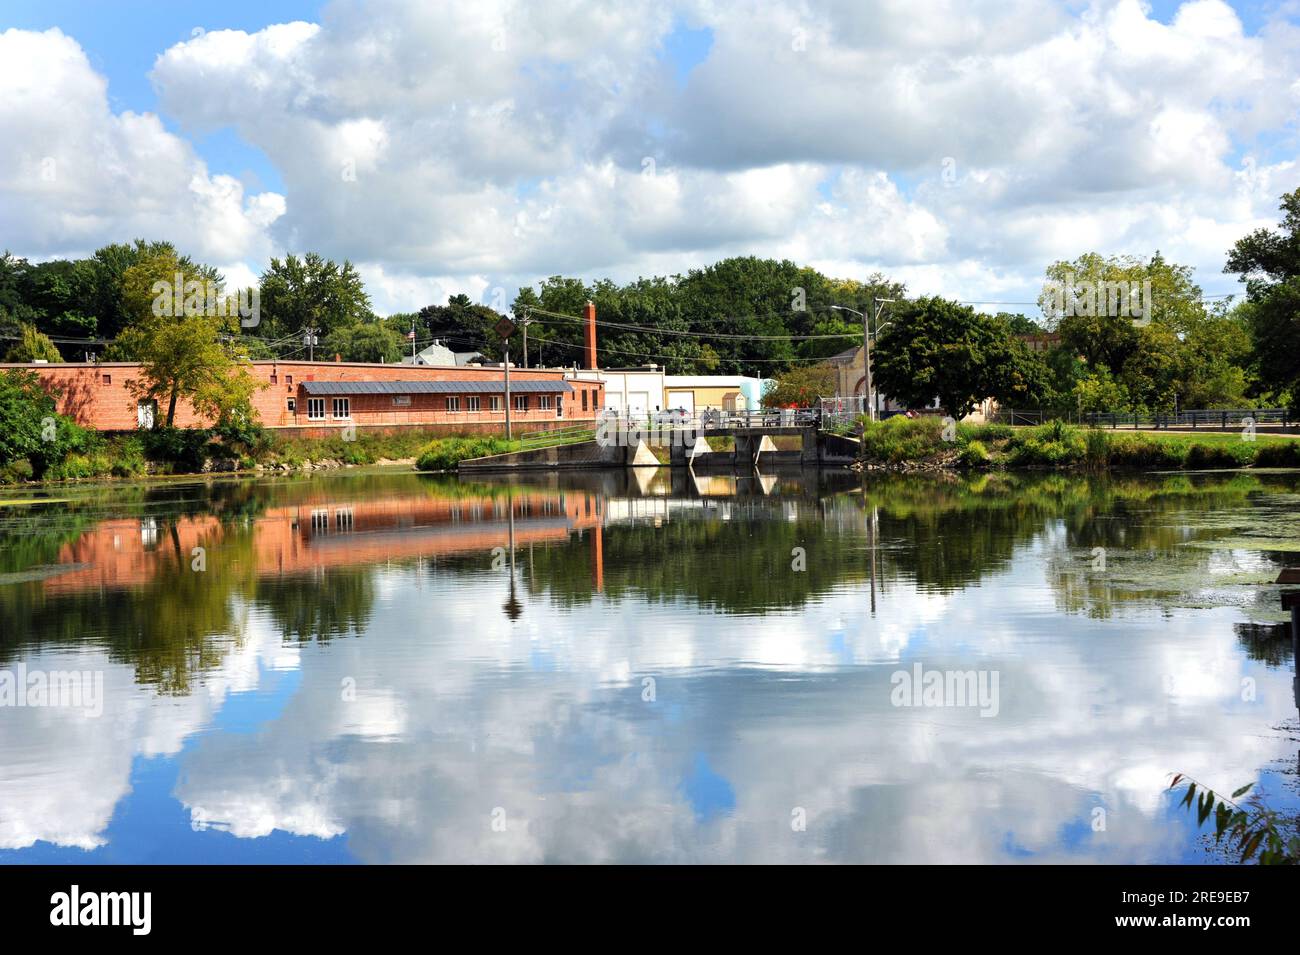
[0,472,1300,863]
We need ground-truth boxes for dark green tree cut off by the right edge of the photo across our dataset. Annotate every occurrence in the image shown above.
[1225,188,1300,408]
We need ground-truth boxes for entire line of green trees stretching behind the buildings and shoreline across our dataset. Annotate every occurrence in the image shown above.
[0,190,1300,422]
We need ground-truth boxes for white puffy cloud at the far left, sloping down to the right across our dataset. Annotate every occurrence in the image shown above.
[0,30,285,264]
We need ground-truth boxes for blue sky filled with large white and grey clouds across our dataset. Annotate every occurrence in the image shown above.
[0,0,1300,311]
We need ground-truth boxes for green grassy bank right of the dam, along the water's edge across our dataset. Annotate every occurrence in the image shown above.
[862,417,1300,470]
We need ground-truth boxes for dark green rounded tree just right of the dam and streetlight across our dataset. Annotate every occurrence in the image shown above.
[872,298,1048,418]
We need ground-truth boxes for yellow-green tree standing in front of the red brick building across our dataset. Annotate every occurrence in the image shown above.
[116,253,260,427]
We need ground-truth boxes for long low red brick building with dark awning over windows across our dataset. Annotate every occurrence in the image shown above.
[0,361,605,434]
